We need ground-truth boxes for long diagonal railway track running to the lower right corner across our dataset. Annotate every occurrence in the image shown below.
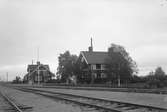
[16,88,167,112]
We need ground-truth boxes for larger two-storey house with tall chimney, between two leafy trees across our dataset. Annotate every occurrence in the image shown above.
[78,39,108,83]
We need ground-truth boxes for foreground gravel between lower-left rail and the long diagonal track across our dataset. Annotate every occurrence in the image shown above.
[0,86,97,112]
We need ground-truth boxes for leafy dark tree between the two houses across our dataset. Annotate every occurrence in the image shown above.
[57,51,78,82]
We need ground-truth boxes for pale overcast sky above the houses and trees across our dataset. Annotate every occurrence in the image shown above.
[0,0,167,80]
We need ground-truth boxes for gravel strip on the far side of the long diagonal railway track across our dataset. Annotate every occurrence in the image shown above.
[31,88,167,109]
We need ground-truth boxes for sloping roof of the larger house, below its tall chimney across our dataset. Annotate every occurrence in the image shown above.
[81,51,108,64]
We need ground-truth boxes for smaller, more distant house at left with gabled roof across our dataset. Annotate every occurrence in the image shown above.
[23,61,55,83]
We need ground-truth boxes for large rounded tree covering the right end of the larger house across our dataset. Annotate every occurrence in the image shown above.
[106,44,138,86]
